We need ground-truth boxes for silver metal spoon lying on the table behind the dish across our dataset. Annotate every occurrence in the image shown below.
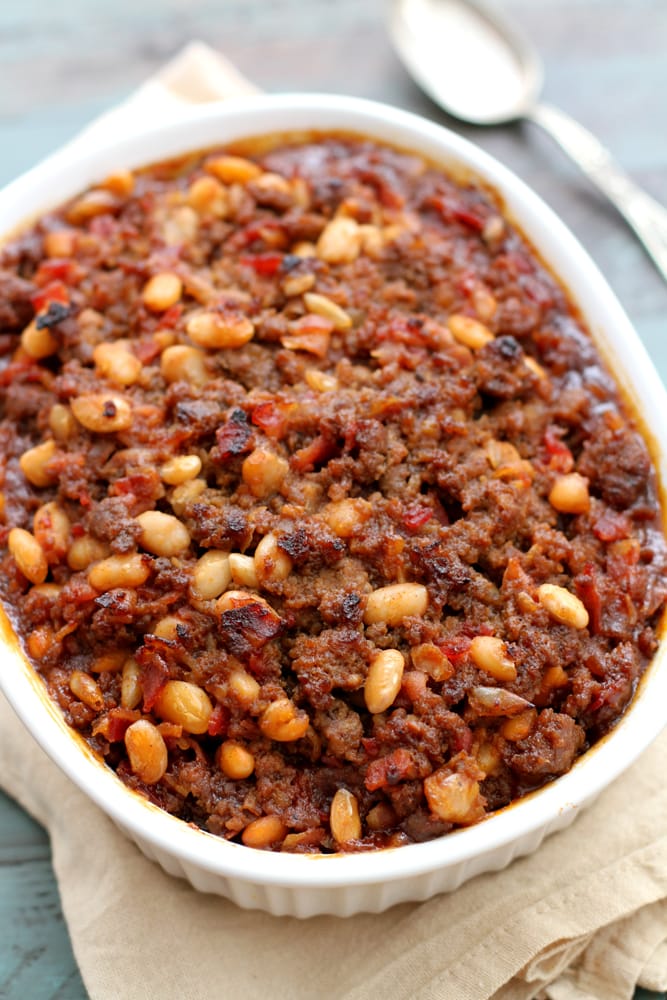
[389,0,667,281]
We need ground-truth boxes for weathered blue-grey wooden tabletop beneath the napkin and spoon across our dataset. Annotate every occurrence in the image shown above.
[0,0,667,1000]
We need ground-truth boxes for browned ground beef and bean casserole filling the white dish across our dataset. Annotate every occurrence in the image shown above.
[0,135,667,853]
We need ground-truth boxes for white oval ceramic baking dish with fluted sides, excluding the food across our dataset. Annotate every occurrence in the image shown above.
[0,95,667,917]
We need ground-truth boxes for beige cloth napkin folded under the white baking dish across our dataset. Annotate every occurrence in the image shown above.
[0,43,667,1000]
